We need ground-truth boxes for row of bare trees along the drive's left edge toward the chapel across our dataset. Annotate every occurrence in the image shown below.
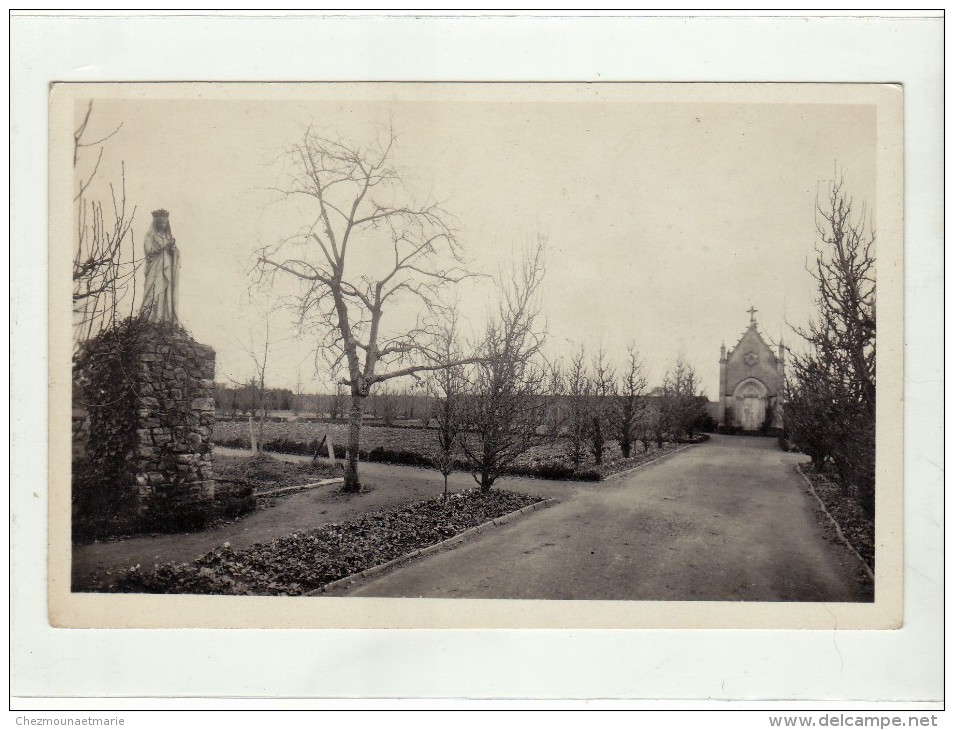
[429,336,707,491]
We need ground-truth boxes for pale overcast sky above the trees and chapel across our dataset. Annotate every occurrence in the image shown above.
[70,85,877,398]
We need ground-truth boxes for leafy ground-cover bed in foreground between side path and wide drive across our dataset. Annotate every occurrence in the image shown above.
[108,489,540,596]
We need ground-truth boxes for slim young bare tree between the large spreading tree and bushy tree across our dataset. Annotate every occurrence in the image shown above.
[427,310,467,504]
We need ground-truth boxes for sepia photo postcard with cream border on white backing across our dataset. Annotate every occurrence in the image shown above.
[49,83,904,629]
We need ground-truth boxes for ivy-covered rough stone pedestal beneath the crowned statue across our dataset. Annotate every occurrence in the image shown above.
[73,319,215,534]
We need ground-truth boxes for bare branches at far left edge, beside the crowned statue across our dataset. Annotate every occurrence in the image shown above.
[73,101,138,345]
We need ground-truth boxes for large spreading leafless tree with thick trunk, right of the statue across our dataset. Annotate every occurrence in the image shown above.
[258,128,480,492]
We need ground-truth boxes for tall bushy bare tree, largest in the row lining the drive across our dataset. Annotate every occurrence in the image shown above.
[461,246,549,491]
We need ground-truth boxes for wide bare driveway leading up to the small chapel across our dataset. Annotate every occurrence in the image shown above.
[336,436,873,602]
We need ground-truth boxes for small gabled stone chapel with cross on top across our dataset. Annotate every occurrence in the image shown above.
[719,307,785,431]
